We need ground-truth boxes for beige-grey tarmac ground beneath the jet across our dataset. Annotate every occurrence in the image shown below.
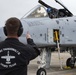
[28,52,76,75]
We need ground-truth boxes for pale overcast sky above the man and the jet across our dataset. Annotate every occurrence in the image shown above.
[0,0,76,27]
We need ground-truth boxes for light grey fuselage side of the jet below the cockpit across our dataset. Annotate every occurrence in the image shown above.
[0,16,76,47]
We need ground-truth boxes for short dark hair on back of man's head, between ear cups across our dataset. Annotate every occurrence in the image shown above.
[5,17,20,35]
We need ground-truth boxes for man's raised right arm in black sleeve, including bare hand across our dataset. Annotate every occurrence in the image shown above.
[26,33,40,60]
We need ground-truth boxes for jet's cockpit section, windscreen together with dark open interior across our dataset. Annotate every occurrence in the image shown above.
[24,1,72,19]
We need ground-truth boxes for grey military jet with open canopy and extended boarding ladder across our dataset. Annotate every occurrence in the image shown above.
[0,0,76,75]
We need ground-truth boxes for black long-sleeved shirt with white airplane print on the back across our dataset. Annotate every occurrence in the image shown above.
[0,38,40,75]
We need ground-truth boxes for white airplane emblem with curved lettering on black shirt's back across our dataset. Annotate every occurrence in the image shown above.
[0,48,20,68]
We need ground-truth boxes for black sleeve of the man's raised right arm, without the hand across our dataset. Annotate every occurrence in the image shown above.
[27,38,40,60]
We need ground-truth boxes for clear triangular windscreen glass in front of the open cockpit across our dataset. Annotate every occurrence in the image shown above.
[26,6,48,18]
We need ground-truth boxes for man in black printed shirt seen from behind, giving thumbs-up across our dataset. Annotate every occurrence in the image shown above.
[0,17,40,75]
